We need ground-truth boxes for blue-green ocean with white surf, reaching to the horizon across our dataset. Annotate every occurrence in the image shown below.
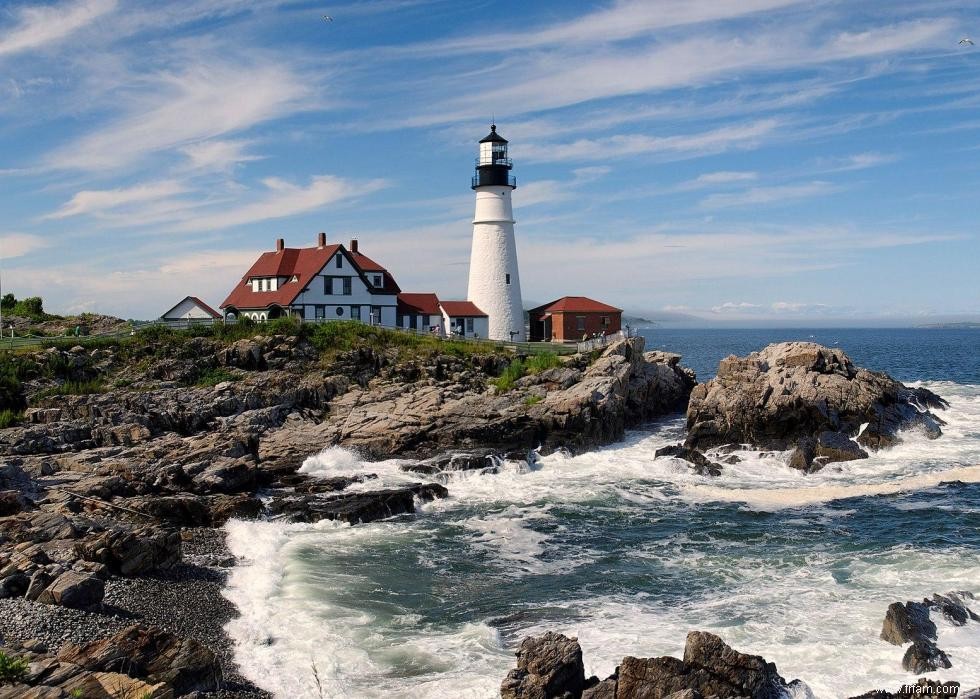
[225,329,980,699]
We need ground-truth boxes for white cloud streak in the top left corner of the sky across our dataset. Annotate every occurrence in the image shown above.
[0,0,116,56]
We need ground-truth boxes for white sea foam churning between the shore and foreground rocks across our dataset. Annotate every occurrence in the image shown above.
[227,383,980,699]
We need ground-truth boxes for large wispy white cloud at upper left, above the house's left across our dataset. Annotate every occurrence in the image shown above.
[46,60,312,171]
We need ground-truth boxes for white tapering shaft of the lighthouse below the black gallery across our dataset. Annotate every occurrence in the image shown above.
[467,186,526,342]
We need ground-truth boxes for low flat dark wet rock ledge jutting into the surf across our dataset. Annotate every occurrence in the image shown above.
[268,483,449,524]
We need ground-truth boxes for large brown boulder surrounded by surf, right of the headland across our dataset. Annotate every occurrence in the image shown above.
[687,342,947,456]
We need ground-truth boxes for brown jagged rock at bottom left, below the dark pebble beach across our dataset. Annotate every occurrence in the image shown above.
[58,625,222,696]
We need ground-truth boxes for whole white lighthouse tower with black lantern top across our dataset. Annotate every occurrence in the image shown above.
[467,124,526,342]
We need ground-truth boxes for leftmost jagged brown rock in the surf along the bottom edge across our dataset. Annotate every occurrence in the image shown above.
[500,631,585,699]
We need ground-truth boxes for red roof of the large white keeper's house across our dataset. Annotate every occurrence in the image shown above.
[221,244,399,308]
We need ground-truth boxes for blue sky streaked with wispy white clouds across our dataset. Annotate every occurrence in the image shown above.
[0,0,980,325]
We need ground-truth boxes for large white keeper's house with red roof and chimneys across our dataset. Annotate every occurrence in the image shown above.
[221,233,400,327]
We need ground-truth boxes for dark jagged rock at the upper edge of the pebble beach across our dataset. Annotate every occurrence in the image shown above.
[75,527,181,575]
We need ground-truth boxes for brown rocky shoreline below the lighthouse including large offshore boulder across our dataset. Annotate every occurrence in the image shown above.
[0,330,956,697]
